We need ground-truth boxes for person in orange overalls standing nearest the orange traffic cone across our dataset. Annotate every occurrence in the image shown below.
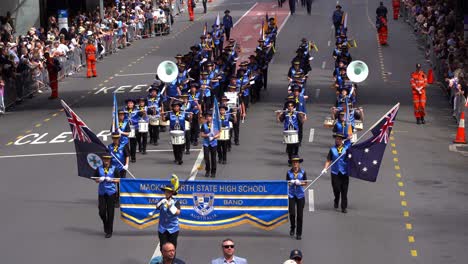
[411,63,427,125]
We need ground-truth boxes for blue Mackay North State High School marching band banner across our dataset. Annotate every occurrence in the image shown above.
[120,179,288,230]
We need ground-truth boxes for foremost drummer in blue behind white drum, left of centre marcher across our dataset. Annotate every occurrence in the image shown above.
[161,100,191,165]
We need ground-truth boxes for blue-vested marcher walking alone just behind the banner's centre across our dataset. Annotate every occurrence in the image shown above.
[201,111,219,178]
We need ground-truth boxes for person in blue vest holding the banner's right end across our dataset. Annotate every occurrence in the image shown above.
[286,155,307,240]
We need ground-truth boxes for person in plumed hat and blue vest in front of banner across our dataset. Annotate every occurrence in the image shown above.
[156,179,180,247]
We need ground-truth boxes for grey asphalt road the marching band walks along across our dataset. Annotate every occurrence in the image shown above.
[0,0,468,264]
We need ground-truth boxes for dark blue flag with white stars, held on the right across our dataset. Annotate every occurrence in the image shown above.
[347,104,400,182]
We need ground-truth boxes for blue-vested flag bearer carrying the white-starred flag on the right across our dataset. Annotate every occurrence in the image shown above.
[322,133,349,213]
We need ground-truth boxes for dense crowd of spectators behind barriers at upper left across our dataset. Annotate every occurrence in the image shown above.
[0,0,179,111]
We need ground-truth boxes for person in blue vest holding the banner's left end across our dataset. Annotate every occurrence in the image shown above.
[94,155,119,238]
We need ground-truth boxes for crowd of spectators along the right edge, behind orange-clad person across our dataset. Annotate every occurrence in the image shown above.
[402,0,468,109]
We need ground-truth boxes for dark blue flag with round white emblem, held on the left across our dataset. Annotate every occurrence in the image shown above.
[61,100,108,178]
